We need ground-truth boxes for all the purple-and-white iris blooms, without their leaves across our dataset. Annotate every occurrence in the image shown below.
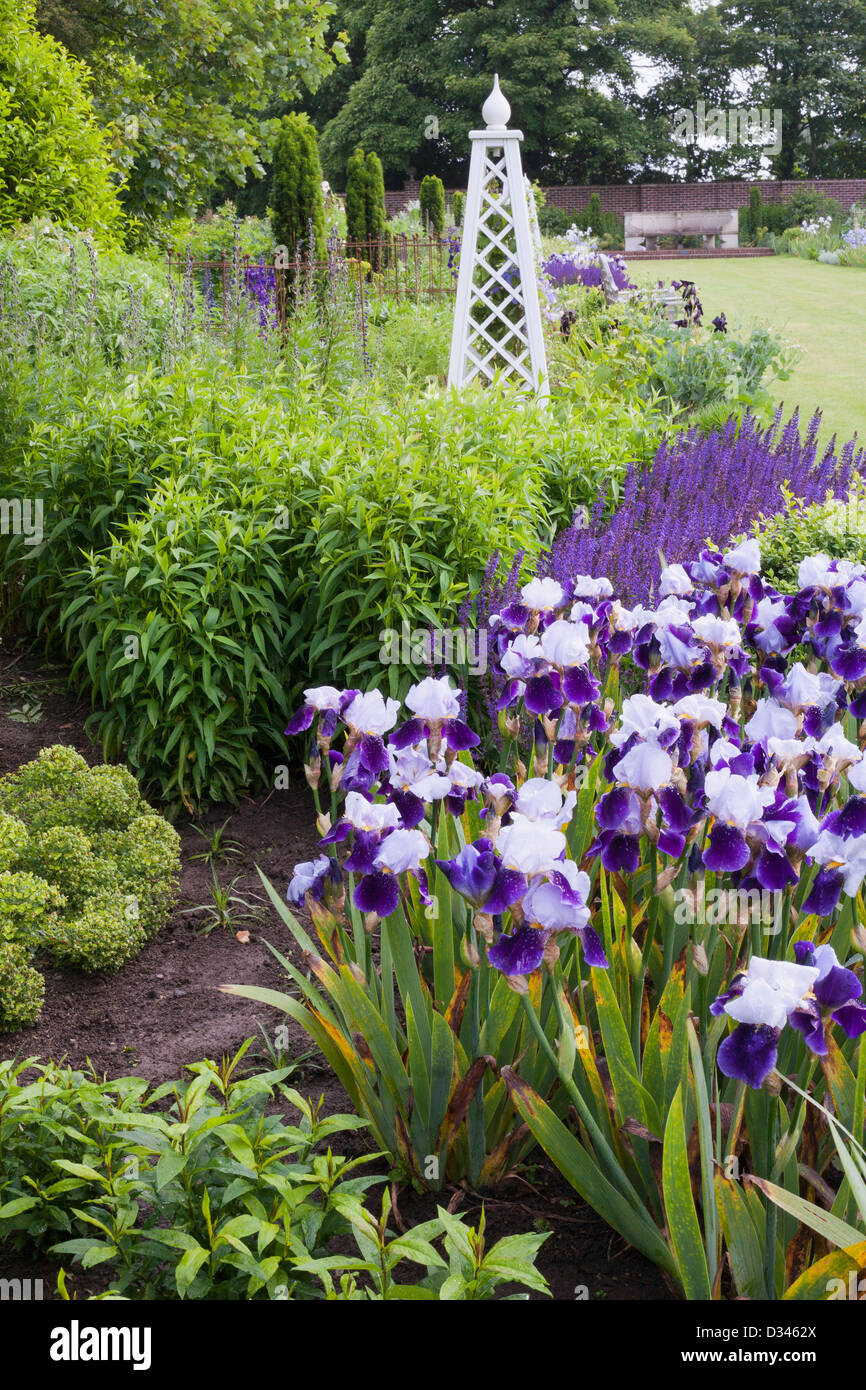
[289,539,866,1050]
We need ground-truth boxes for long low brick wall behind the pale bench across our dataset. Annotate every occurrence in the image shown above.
[385,178,866,217]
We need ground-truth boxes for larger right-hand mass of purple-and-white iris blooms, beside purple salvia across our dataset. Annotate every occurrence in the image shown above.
[480,539,866,1056]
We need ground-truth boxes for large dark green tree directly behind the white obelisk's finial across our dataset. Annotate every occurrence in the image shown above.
[314,0,661,182]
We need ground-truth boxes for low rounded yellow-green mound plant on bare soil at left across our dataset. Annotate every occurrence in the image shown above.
[0,745,179,1029]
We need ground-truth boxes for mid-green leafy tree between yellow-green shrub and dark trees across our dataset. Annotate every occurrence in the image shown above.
[39,0,345,221]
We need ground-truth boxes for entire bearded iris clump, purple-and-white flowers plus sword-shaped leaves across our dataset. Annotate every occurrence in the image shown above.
[234,539,866,1298]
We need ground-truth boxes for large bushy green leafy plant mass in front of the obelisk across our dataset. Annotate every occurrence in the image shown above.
[38,364,631,813]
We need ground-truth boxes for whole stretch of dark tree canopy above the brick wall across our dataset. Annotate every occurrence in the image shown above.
[304,0,866,186]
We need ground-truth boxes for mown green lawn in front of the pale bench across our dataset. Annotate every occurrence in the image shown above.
[628,256,866,453]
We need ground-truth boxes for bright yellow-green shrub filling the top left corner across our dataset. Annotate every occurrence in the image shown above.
[0,0,121,246]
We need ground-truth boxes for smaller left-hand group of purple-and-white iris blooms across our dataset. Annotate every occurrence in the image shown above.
[286,669,607,988]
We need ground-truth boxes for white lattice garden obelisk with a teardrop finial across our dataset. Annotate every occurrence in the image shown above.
[448,76,549,399]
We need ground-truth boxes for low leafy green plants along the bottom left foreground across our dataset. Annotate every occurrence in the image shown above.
[0,1041,548,1301]
